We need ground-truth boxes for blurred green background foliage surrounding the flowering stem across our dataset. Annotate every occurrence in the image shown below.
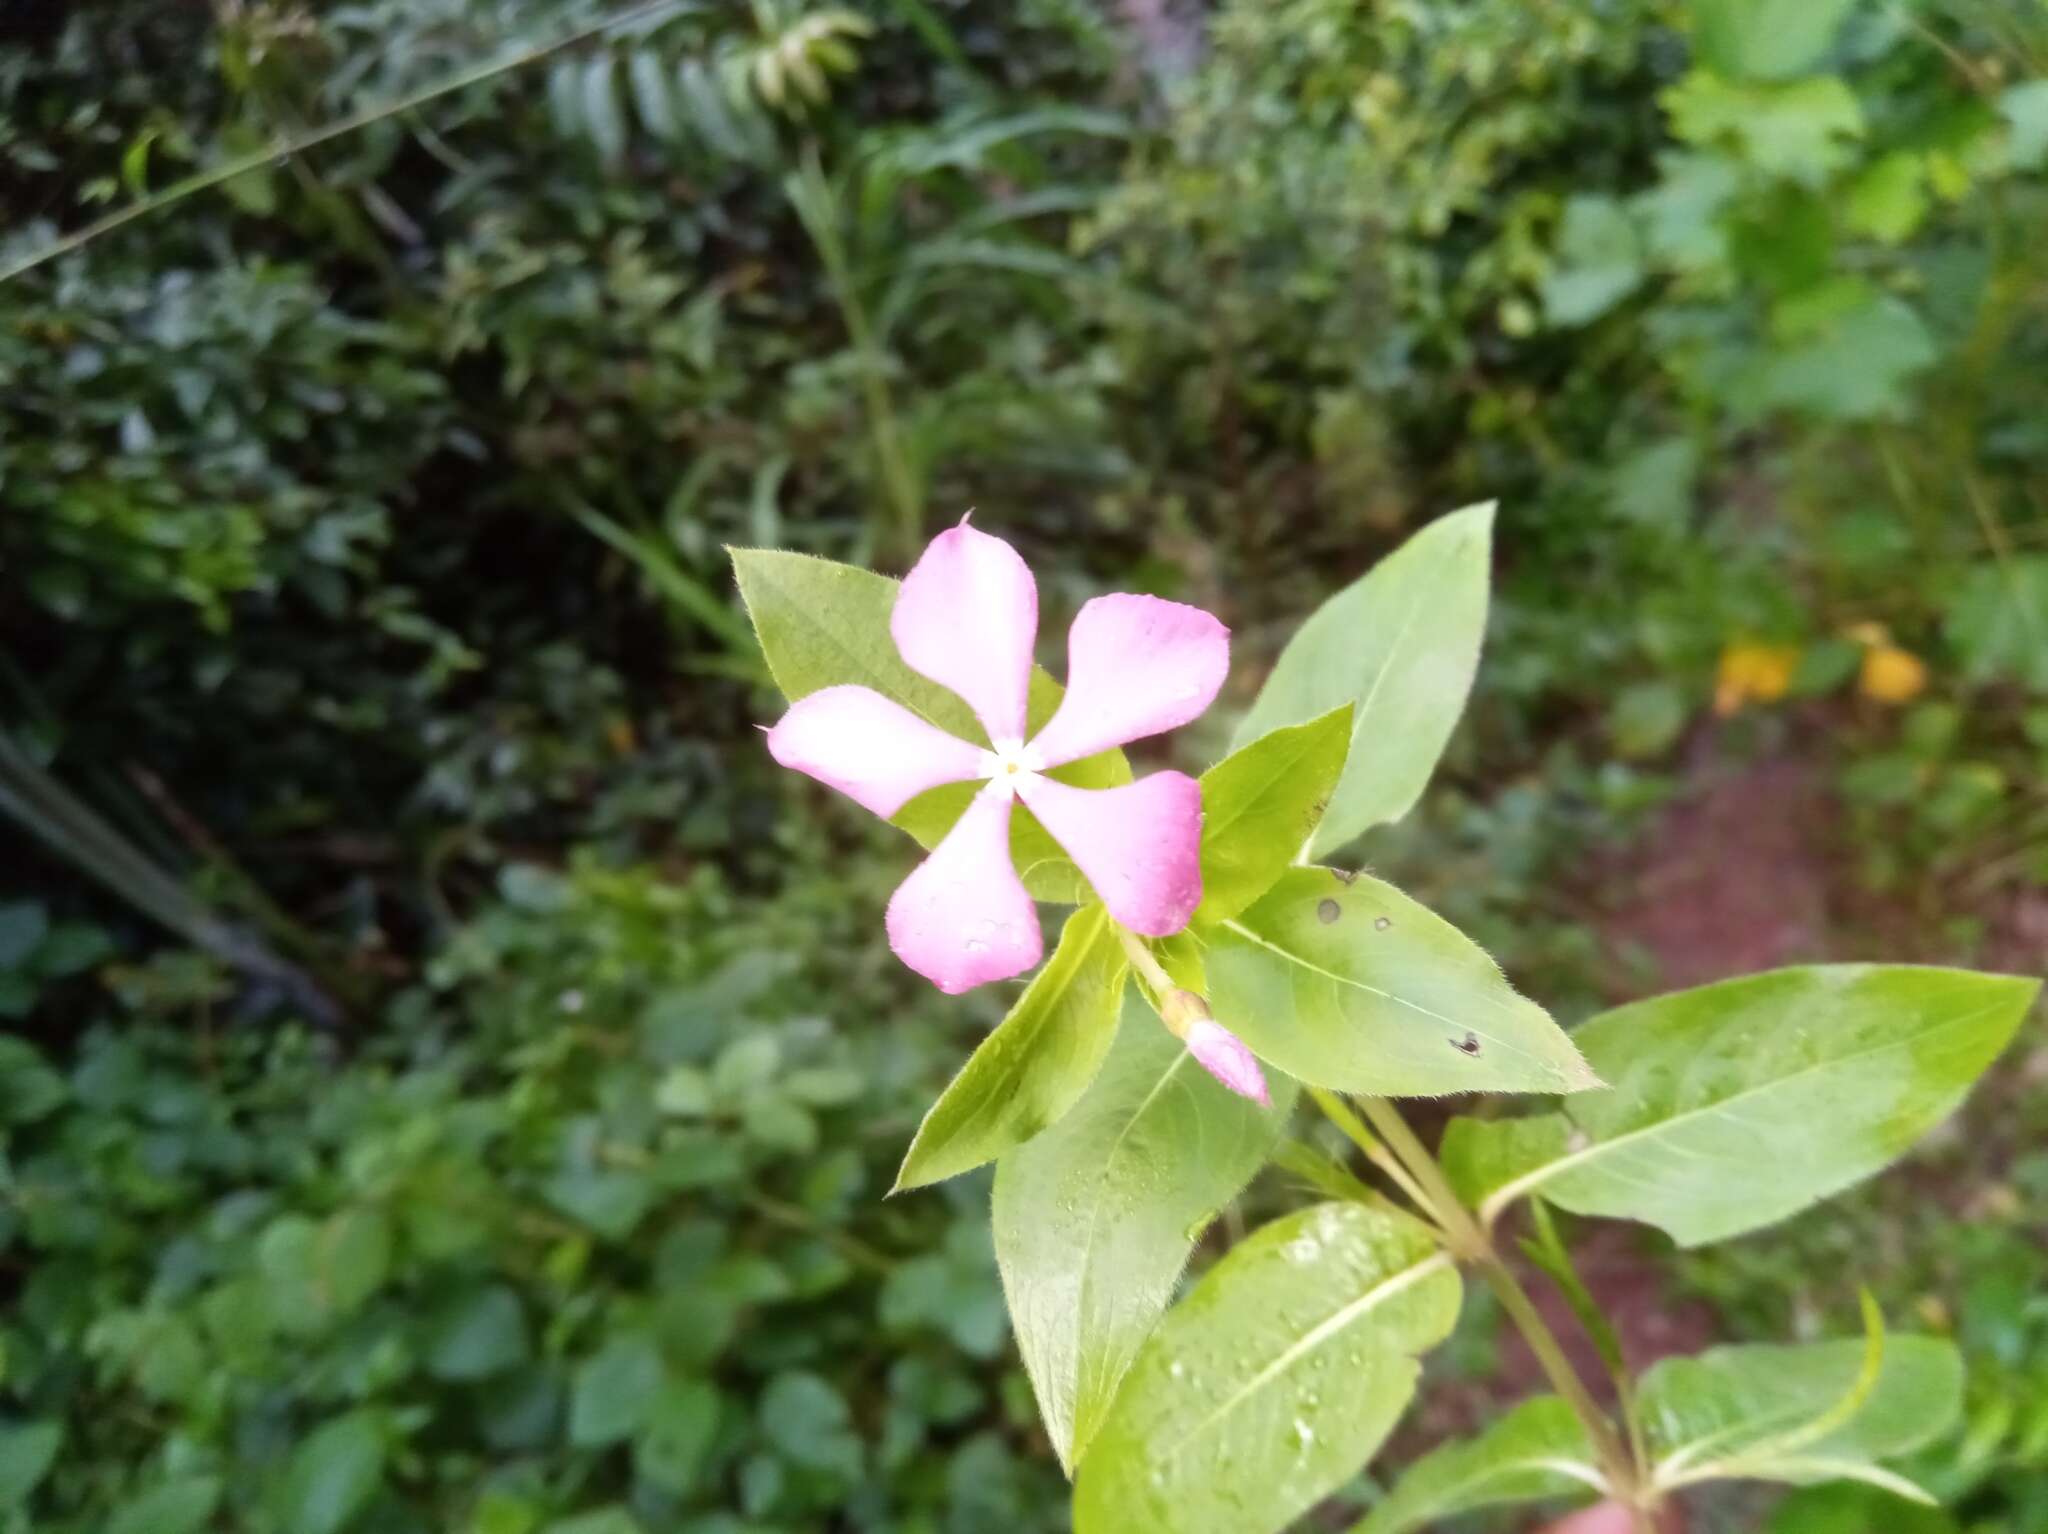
[0,0,2048,1534]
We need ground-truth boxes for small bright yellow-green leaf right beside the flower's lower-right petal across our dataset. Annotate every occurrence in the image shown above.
[1194,702,1352,922]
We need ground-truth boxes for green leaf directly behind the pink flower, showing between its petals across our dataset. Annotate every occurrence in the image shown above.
[731,549,1130,905]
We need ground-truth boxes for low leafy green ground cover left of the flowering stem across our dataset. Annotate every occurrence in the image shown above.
[0,862,1061,1534]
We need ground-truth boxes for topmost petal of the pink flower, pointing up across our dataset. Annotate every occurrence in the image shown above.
[889,520,1038,745]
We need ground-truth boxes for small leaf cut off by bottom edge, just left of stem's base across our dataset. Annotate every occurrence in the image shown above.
[1352,1395,1606,1534]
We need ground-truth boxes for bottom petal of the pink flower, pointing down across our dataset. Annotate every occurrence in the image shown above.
[889,786,1044,995]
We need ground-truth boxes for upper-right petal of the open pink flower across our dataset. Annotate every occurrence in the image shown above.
[1015,594,1231,766]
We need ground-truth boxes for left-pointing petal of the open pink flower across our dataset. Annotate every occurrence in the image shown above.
[768,686,983,817]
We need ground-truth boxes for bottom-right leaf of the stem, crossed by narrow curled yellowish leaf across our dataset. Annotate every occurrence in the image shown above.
[1640,1337,1962,1501]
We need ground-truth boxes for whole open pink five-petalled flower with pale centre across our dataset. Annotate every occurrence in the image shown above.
[768,520,1231,993]
